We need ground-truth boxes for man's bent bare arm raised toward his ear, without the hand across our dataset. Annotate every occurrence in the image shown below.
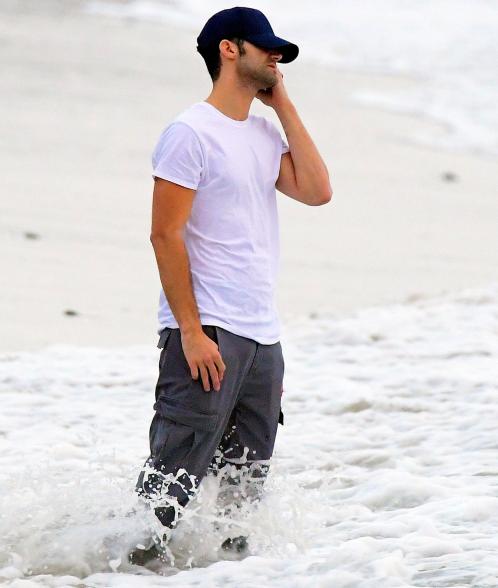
[274,99,332,206]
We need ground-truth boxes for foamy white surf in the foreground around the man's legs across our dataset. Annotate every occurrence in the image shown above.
[0,283,498,588]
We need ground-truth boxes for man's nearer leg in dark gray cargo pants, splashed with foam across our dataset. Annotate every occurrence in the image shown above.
[136,326,256,544]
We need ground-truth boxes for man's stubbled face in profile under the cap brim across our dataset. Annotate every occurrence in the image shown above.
[236,41,282,90]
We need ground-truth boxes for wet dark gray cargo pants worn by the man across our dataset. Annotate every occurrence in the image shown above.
[135,325,284,527]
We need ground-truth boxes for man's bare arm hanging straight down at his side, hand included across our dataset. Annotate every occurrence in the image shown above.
[150,177,225,391]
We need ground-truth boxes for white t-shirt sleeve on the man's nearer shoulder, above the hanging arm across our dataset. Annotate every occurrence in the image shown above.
[152,121,204,190]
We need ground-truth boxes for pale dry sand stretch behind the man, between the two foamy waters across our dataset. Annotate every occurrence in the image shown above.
[0,2,498,351]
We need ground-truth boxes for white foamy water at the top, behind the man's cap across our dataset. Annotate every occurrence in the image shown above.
[85,0,498,158]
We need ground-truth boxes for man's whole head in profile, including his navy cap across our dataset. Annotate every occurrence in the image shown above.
[197,6,299,87]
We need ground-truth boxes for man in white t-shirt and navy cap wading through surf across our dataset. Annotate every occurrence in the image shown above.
[130,7,332,563]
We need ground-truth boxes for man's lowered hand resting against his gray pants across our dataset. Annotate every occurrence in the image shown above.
[181,330,226,392]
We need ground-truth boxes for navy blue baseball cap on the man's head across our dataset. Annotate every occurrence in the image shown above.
[197,6,299,63]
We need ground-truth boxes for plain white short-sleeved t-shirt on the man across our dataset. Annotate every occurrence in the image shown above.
[152,101,289,344]
